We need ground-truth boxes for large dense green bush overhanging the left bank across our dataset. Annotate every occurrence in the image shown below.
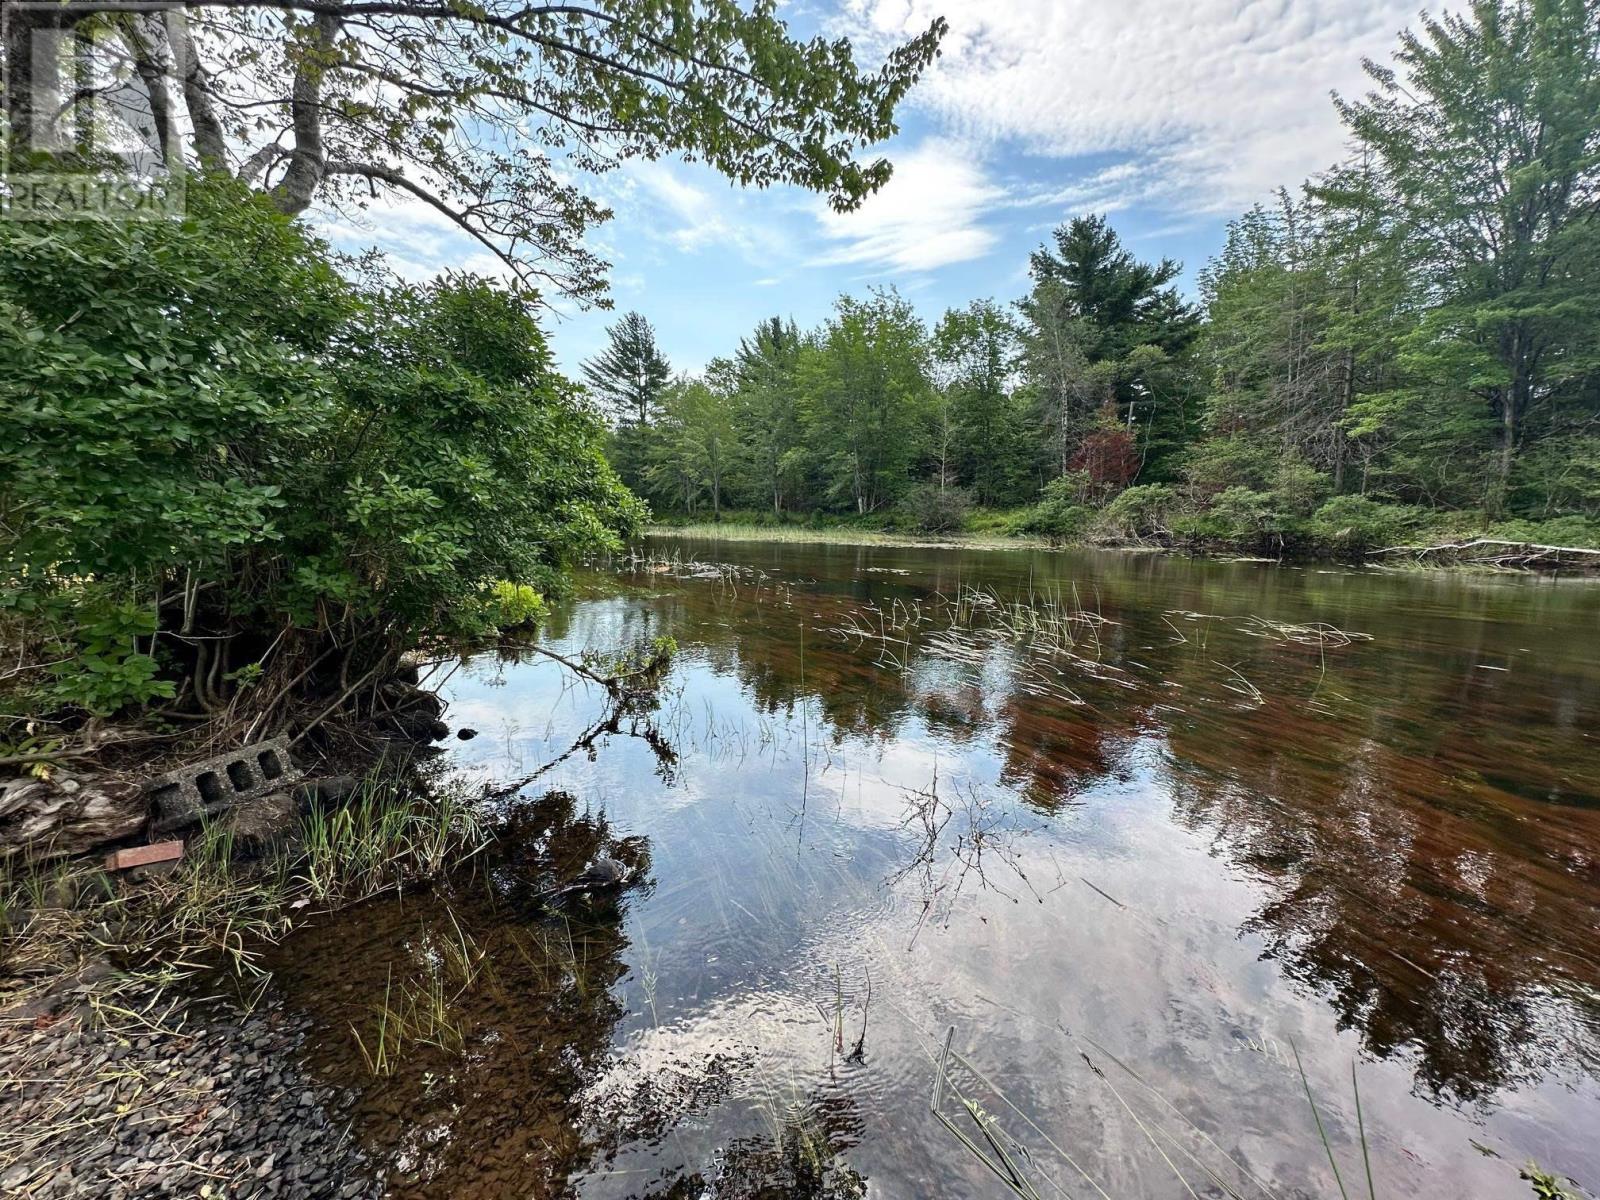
[0,179,642,723]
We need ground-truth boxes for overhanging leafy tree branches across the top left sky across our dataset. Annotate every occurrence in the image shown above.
[5,0,946,299]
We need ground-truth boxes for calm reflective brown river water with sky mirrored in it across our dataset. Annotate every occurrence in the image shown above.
[268,542,1600,1200]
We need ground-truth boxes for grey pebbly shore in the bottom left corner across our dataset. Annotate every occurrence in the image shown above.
[0,979,384,1200]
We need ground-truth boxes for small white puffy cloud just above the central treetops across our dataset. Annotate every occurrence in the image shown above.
[813,139,1006,272]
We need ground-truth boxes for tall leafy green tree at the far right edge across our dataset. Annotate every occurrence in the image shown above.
[1339,0,1600,509]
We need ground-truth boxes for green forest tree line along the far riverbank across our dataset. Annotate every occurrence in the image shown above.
[584,0,1600,549]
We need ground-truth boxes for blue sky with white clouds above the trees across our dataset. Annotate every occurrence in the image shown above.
[305,0,1418,373]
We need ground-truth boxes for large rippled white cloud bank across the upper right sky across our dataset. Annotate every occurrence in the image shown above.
[840,0,1440,211]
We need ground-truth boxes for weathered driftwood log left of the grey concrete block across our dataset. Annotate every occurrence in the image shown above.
[0,766,150,858]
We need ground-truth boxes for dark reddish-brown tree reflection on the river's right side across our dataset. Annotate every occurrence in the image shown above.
[611,554,1600,1101]
